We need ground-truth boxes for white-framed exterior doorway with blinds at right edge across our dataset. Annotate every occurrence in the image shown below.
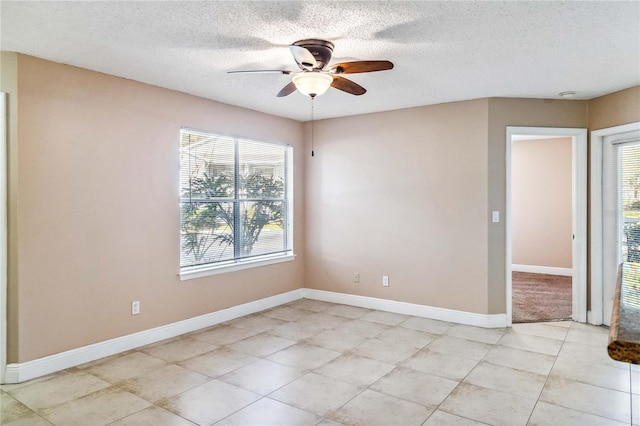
[589,122,640,325]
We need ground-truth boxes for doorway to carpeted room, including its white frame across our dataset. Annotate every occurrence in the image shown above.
[505,127,587,325]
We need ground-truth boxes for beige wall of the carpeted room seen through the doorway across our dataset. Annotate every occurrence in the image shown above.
[511,138,572,268]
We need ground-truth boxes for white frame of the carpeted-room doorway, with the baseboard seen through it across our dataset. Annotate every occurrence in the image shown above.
[505,127,587,325]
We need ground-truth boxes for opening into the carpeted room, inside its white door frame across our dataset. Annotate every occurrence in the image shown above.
[511,135,573,323]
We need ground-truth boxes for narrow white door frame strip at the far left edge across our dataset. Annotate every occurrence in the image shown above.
[0,92,8,383]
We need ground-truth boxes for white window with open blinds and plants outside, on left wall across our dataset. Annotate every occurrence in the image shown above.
[180,129,293,278]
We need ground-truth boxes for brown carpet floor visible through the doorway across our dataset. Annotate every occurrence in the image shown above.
[511,272,571,323]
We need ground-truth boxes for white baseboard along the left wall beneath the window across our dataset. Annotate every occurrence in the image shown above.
[5,289,303,383]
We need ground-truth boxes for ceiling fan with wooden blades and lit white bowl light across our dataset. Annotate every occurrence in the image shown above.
[229,39,393,98]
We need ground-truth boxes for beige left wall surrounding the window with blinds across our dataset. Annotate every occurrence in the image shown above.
[8,55,304,362]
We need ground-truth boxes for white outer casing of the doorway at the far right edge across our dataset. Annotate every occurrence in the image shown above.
[589,121,640,325]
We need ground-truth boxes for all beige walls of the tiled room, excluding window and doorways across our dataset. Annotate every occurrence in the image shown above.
[0,50,640,362]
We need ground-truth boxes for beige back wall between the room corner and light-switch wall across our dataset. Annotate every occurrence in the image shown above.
[305,99,488,314]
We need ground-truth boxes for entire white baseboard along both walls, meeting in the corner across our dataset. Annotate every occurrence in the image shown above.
[5,288,507,384]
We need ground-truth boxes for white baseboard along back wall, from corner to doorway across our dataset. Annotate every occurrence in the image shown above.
[303,288,507,328]
